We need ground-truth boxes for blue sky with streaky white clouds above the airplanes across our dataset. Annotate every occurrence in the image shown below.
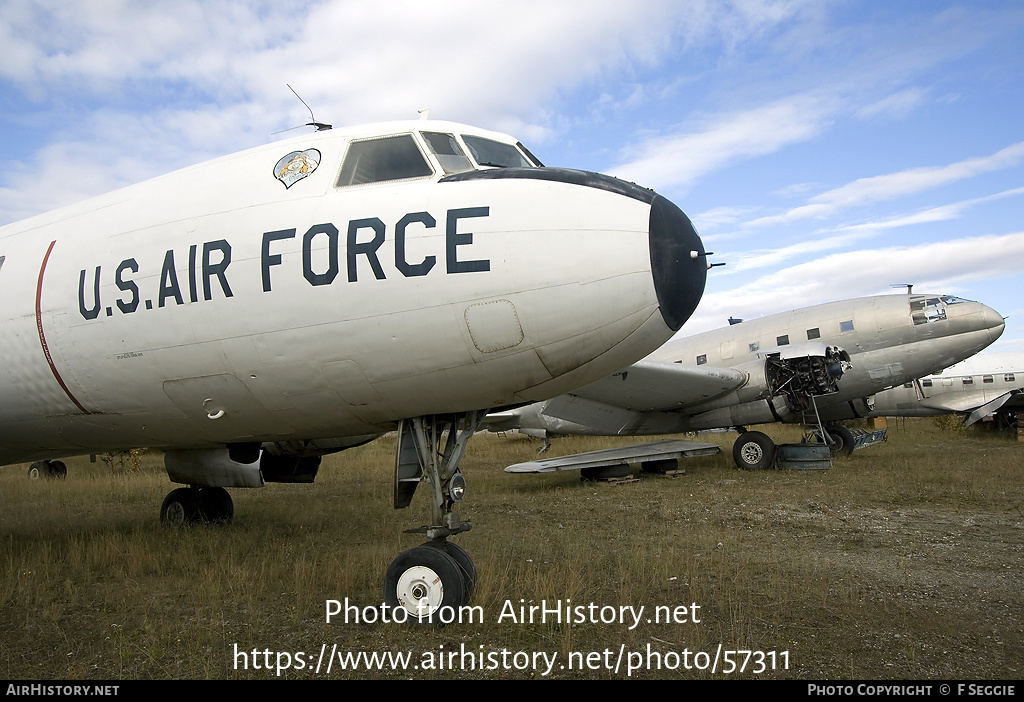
[0,0,1024,362]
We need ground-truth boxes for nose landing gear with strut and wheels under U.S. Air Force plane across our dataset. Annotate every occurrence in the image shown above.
[384,411,485,625]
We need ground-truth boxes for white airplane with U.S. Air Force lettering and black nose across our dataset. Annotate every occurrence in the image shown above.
[0,121,708,619]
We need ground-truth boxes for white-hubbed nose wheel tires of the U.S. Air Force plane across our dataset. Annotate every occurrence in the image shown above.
[384,544,475,625]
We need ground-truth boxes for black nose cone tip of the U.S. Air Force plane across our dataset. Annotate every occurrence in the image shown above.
[649,195,708,332]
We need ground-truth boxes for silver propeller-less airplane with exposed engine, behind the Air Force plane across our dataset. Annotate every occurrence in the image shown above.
[488,295,1004,470]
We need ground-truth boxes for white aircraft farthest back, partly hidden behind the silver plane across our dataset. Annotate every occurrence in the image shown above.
[871,353,1024,431]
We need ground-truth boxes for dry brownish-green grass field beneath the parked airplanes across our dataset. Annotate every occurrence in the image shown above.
[0,421,1024,679]
